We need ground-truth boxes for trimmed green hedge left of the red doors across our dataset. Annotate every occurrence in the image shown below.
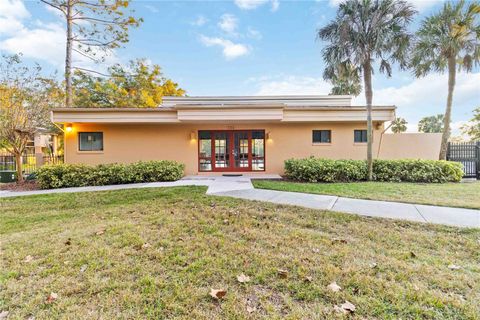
[36,160,185,189]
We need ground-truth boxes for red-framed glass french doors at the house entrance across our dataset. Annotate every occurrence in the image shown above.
[198,130,265,172]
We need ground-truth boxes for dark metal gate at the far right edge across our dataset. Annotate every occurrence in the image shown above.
[447,141,480,179]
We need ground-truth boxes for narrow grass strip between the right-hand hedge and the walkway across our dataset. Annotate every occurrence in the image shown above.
[252,180,480,209]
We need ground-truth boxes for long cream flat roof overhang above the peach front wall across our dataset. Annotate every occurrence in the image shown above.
[51,104,396,123]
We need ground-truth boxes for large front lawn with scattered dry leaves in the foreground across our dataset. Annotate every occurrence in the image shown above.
[0,187,480,319]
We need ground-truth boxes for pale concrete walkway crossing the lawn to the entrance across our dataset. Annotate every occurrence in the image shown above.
[0,175,480,228]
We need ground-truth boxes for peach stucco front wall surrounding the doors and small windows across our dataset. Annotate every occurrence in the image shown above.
[65,123,383,174]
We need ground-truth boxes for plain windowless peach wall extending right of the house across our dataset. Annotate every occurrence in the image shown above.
[378,133,442,160]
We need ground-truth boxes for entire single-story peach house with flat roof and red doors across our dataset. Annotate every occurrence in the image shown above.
[52,95,440,174]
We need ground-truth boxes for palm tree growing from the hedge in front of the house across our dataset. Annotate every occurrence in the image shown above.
[318,0,416,180]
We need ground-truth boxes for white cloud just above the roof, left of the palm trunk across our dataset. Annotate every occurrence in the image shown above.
[248,75,331,96]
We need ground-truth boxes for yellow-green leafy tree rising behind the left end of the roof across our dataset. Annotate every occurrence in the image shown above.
[73,59,185,108]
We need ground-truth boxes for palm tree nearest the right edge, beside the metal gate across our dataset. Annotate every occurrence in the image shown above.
[411,0,480,160]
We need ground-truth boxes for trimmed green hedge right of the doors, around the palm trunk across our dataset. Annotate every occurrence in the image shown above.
[285,157,463,183]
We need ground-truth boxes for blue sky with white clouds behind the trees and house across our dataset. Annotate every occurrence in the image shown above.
[0,0,480,132]
